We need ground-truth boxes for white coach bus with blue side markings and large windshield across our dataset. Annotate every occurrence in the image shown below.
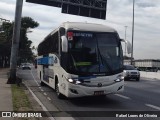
[37,22,131,98]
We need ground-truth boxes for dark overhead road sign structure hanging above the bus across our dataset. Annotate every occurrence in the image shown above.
[26,0,107,19]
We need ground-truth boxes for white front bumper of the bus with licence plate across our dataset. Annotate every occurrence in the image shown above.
[66,81,124,98]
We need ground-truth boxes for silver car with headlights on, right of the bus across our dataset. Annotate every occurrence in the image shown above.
[123,65,140,81]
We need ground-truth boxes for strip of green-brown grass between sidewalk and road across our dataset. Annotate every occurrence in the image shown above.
[11,84,33,111]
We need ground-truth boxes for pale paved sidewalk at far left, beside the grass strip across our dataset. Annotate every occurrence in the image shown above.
[0,68,13,120]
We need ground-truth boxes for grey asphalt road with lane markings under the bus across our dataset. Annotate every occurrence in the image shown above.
[18,68,160,120]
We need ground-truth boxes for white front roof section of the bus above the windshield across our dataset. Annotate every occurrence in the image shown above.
[60,22,116,32]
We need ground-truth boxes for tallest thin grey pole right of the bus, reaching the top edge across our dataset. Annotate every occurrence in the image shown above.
[131,0,135,65]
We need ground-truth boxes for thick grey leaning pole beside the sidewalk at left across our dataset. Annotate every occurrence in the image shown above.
[7,0,23,84]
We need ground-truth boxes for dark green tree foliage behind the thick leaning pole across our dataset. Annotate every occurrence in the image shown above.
[0,17,39,67]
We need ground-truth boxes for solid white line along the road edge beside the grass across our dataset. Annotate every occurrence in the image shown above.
[25,84,55,120]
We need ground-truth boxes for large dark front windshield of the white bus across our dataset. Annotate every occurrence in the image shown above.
[68,32,123,75]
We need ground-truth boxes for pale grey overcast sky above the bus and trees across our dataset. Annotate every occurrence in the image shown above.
[0,0,160,59]
